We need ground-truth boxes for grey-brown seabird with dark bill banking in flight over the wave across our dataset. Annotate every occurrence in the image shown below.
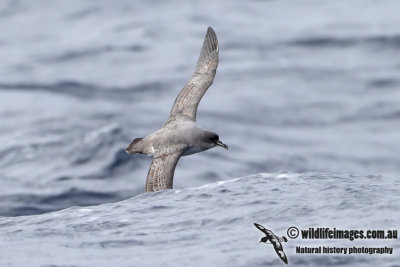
[126,27,228,192]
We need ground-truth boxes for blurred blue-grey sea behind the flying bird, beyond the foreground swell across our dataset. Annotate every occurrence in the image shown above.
[0,0,400,266]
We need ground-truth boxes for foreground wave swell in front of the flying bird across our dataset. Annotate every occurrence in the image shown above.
[0,171,400,266]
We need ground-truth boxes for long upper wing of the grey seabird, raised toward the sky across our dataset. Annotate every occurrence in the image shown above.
[167,27,218,124]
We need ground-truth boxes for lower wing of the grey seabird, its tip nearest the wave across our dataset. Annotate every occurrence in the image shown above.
[146,150,183,192]
